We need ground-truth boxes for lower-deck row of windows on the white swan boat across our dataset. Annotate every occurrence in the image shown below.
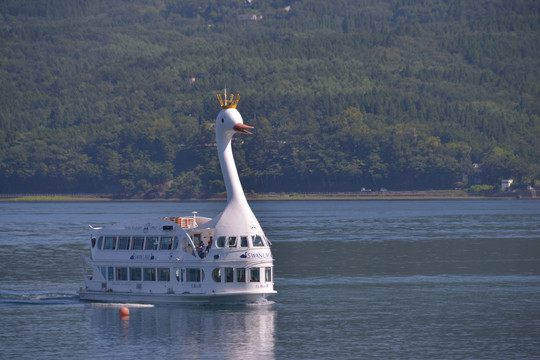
[100,266,272,283]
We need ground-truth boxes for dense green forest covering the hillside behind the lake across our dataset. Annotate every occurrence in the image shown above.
[0,0,540,198]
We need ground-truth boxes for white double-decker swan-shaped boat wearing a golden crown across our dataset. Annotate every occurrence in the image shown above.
[79,91,276,304]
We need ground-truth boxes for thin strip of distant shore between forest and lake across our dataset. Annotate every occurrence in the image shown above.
[0,190,537,202]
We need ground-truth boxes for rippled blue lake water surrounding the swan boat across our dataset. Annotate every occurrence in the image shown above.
[0,200,540,360]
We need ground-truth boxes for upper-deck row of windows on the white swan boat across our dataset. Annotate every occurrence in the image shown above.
[92,235,266,250]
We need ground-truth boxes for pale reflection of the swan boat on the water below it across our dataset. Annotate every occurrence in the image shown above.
[84,304,276,360]
